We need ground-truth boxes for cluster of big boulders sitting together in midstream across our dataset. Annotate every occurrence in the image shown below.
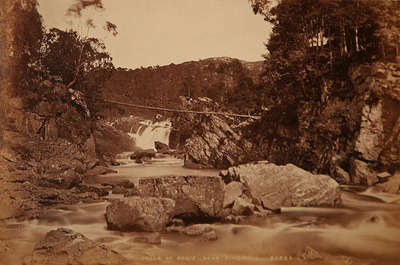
[106,161,341,232]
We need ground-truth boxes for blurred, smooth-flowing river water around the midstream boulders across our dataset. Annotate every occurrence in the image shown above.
[0,158,400,265]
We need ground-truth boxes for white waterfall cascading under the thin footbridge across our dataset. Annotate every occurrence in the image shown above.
[129,120,172,150]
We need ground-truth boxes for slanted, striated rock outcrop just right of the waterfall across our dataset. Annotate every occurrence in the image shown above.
[171,97,252,169]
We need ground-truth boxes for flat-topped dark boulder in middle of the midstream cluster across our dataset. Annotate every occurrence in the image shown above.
[135,176,224,217]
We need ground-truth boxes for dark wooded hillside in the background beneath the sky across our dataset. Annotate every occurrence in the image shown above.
[103,57,264,116]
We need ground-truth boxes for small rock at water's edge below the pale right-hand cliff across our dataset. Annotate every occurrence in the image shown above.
[350,159,379,186]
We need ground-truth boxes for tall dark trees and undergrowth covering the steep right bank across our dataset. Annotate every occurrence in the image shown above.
[249,0,400,177]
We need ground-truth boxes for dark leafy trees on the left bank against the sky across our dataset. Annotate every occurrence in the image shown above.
[12,0,116,143]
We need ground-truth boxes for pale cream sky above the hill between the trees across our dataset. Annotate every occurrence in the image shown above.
[39,0,271,69]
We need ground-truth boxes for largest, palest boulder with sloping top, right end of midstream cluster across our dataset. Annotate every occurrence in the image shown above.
[221,162,340,209]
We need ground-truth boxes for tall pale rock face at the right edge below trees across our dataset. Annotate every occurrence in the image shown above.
[350,63,400,185]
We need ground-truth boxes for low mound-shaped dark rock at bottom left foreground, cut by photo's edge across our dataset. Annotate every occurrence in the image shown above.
[25,228,127,265]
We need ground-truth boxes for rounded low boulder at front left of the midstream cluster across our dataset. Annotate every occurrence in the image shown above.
[106,197,175,232]
